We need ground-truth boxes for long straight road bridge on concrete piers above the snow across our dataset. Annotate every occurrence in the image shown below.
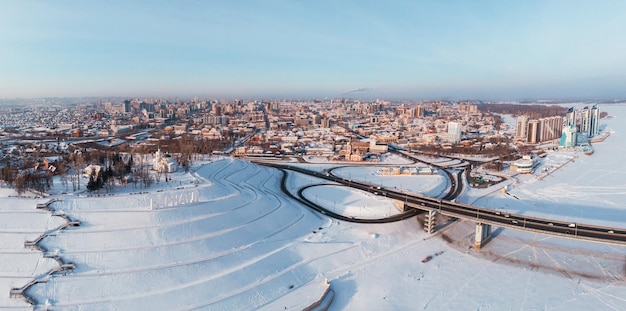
[256,161,626,249]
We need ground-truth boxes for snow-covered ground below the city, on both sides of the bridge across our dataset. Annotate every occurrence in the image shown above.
[0,106,626,310]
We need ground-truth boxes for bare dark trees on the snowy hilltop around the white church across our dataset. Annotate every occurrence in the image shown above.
[0,135,232,195]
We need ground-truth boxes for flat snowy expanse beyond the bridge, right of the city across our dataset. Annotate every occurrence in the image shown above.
[469,105,626,227]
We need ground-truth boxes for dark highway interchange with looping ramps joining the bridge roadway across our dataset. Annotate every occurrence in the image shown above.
[250,153,626,249]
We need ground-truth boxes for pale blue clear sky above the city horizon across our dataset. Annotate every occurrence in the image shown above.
[0,0,626,99]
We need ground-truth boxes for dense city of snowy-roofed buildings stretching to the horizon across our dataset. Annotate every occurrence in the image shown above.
[0,97,608,193]
